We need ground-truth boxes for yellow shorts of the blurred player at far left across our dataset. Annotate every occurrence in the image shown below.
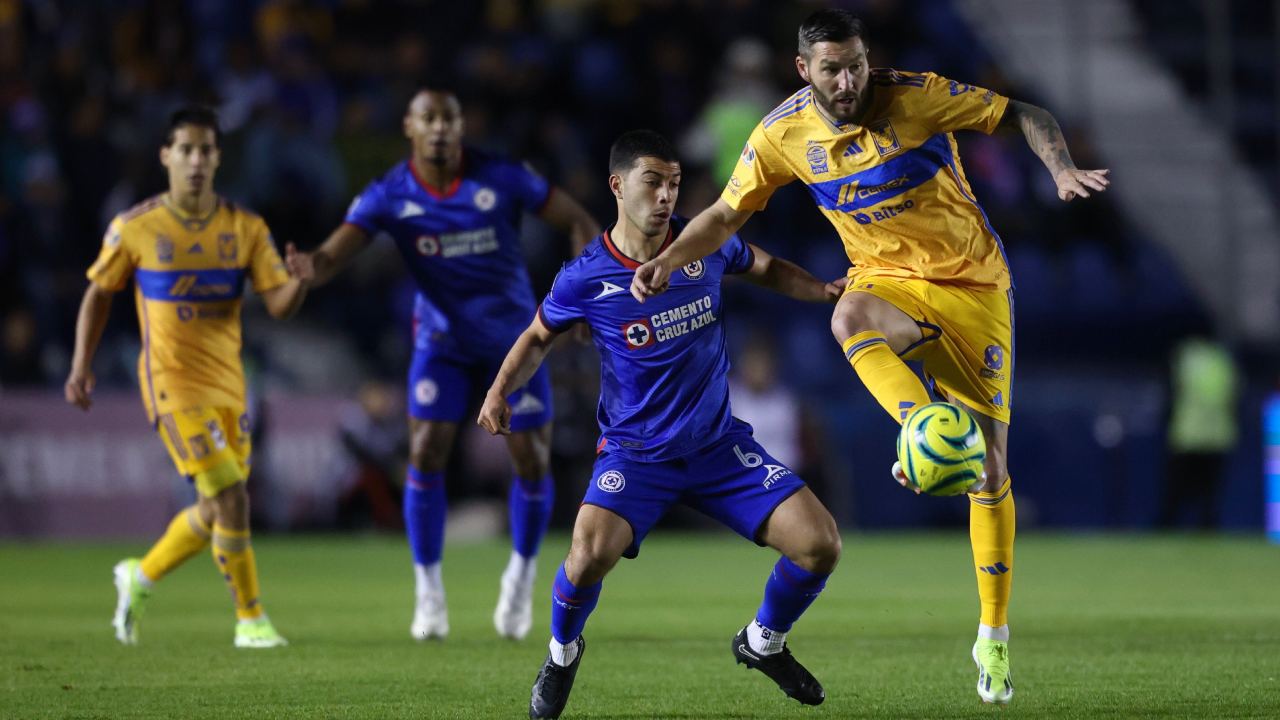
[156,406,251,497]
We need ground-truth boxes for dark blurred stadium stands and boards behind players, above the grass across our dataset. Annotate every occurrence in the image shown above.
[0,0,1280,537]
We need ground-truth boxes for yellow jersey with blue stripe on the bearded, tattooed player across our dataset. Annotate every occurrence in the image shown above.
[721,68,1010,290]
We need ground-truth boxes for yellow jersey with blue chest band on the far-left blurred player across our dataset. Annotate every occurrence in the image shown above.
[87,195,289,423]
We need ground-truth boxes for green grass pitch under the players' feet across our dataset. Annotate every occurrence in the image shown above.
[0,529,1280,719]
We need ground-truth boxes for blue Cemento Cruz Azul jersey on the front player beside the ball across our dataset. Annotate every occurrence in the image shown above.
[539,218,755,461]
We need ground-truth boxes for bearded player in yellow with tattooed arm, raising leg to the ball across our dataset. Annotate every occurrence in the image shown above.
[631,10,1108,703]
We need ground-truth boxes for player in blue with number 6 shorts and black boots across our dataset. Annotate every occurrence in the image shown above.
[479,131,841,717]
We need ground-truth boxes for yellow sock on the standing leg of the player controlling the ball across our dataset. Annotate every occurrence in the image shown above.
[969,478,1015,628]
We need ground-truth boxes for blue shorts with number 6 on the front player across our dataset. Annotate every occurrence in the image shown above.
[582,432,805,557]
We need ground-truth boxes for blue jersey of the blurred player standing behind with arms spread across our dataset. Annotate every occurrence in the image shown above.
[347,147,550,361]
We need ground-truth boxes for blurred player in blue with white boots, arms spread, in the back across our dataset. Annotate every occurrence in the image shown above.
[292,90,599,639]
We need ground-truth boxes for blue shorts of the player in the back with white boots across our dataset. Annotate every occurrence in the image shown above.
[408,350,552,433]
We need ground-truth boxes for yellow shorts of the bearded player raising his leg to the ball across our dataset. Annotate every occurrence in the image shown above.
[845,268,1014,423]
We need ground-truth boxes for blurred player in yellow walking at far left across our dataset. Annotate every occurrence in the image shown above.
[65,106,310,647]
